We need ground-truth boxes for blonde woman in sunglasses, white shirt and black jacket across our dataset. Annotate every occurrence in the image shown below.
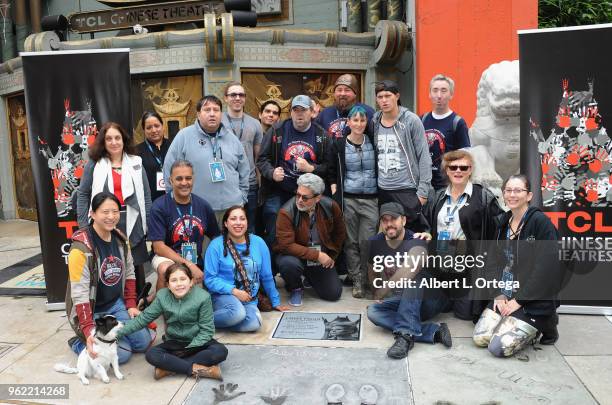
[425,149,503,320]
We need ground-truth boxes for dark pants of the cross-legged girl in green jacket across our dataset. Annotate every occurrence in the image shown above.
[145,339,227,375]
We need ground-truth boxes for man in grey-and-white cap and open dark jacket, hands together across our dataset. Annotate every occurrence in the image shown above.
[257,94,329,248]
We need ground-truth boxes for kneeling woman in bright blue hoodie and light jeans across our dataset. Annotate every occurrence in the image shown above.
[204,205,288,332]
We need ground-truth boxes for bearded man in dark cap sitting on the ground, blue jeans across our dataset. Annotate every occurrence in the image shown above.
[368,202,453,359]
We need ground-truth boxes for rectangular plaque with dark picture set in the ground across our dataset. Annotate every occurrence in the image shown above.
[272,312,361,341]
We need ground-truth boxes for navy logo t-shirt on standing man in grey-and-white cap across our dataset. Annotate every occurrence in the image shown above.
[279,120,319,194]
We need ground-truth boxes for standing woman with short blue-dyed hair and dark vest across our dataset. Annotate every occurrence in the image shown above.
[329,105,378,298]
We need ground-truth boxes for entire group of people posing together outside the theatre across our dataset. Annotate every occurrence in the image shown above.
[66,74,558,379]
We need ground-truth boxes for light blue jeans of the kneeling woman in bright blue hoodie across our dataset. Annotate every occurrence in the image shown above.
[212,294,261,332]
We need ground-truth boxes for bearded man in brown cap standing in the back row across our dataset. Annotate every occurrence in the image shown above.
[317,73,374,138]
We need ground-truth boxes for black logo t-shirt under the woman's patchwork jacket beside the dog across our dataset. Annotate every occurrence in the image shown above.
[92,231,125,312]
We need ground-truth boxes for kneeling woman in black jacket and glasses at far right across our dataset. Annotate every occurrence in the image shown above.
[473,174,563,357]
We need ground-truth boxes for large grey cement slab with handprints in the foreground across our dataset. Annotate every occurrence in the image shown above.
[184,345,413,405]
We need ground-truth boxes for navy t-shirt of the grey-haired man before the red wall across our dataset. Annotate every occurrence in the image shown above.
[423,111,470,189]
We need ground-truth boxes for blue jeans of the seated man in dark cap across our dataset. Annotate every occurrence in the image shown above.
[368,270,452,343]
